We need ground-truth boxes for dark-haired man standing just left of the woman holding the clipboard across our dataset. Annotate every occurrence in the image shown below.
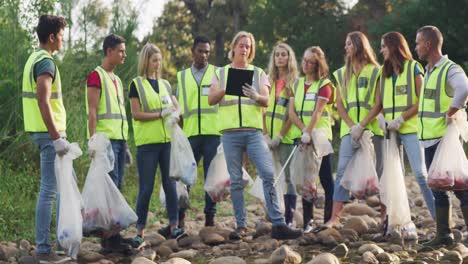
[176,36,220,227]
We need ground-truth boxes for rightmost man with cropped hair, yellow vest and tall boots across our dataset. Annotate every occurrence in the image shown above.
[415,26,468,248]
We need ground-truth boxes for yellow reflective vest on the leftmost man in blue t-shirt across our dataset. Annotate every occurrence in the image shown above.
[22,49,67,132]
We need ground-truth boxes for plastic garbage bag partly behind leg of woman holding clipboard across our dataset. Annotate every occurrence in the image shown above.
[204,144,253,202]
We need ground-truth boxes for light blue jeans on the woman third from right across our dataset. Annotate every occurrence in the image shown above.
[333,134,383,202]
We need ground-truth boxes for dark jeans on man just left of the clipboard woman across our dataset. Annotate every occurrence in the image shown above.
[187,135,220,215]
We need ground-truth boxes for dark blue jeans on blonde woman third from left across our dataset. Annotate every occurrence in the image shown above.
[136,143,179,230]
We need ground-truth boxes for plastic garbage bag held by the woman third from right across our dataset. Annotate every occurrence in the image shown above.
[340,130,379,199]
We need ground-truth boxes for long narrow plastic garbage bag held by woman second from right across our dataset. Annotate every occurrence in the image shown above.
[380,131,417,238]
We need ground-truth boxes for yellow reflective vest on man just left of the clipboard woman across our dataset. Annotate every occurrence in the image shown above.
[177,65,219,137]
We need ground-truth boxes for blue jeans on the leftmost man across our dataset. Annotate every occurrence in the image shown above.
[31,133,59,254]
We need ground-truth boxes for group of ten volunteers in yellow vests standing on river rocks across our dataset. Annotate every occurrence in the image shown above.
[23,12,468,260]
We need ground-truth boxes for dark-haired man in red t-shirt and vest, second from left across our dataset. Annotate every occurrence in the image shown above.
[85,34,132,253]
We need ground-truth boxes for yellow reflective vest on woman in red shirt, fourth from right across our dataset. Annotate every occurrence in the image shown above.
[294,78,333,140]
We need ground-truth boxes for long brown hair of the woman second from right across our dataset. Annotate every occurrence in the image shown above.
[382,32,413,78]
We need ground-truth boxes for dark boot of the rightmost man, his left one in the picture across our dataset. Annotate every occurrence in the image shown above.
[422,206,454,249]
